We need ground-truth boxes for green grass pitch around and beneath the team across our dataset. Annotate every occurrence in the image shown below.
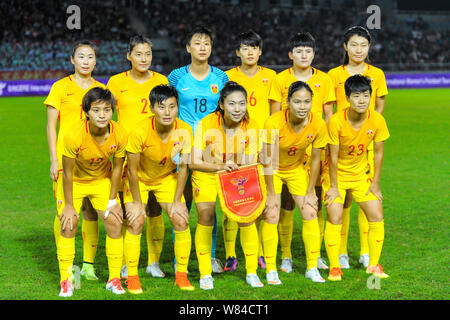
[0,89,450,300]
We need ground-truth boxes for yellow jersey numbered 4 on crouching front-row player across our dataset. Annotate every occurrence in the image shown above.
[126,116,194,185]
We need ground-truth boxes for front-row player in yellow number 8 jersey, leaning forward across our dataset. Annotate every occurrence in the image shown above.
[262,81,328,284]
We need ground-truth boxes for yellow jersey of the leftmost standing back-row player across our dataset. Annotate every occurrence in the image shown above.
[44,76,105,166]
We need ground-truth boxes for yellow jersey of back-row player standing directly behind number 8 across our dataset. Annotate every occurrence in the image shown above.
[269,67,336,118]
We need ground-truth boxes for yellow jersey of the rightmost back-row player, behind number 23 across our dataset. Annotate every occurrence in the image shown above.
[328,63,388,111]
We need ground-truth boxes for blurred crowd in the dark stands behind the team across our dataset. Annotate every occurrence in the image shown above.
[0,0,450,75]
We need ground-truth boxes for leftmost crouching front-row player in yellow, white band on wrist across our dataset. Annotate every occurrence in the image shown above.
[57,87,127,297]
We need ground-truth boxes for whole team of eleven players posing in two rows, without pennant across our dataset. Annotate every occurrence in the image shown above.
[44,27,389,297]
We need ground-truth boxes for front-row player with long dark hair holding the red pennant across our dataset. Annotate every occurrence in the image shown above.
[190,81,263,290]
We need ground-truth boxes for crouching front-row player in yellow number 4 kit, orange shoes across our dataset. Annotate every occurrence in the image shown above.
[124,85,194,294]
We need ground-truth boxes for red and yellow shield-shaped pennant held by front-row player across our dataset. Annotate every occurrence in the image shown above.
[216,165,266,223]
